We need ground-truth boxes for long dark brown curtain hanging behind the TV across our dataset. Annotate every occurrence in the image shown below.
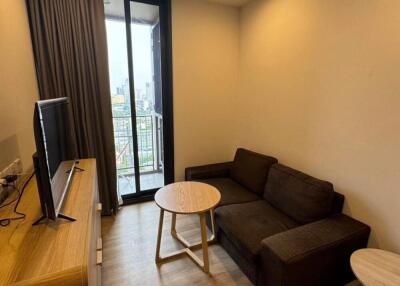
[26,0,118,214]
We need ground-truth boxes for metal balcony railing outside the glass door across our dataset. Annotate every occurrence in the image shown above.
[113,114,163,175]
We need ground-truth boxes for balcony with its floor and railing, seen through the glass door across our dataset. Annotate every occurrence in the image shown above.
[113,112,164,195]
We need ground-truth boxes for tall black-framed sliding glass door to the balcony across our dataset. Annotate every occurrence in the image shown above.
[105,0,174,202]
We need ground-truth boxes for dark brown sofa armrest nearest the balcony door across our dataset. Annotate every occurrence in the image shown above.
[185,162,233,181]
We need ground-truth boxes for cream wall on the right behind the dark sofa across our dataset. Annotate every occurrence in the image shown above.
[236,0,400,252]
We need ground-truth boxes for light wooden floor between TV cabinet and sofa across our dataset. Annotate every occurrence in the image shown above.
[102,202,252,286]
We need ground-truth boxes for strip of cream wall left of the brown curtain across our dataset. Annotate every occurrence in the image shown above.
[0,0,39,169]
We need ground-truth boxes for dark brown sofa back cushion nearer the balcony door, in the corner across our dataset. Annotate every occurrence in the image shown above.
[230,148,278,196]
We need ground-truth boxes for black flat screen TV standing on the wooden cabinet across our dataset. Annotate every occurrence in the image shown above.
[33,98,78,224]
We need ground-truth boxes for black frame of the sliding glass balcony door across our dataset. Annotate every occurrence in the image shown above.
[122,0,175,205]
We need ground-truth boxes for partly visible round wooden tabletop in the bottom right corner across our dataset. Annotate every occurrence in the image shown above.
[350,248,400,286]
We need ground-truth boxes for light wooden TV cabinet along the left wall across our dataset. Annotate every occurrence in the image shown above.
[0,159,102,286]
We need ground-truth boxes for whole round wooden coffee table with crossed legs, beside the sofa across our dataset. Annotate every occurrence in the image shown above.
[155,182,221,273]
